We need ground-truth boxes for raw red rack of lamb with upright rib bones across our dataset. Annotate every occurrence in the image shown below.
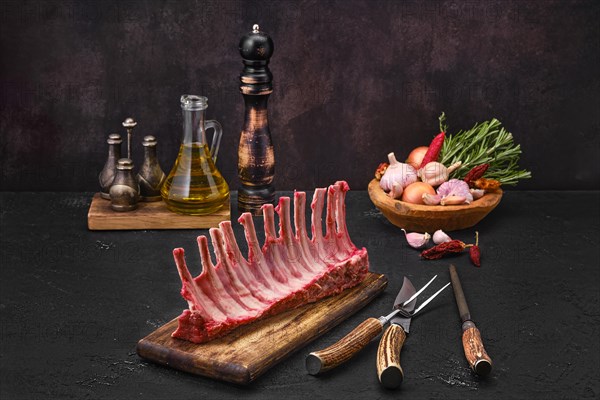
[172,181,369,343]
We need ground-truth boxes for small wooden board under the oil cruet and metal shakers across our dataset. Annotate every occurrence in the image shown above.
[88,193,231,231]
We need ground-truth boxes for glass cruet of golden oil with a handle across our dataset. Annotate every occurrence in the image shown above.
[161,95,229,215]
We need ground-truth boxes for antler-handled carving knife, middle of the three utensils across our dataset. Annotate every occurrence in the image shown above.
[377,277,418,389]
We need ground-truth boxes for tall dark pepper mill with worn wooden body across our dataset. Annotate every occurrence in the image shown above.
[238,25,275,215]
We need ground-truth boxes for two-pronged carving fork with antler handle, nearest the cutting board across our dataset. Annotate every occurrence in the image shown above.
[306,277,418,375]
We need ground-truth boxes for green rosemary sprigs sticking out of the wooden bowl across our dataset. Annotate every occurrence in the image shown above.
[440,116,531,185]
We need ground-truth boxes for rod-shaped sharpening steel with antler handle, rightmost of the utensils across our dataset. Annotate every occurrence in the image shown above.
[450,264,492,376]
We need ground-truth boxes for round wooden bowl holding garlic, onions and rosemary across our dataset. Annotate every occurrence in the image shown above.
[369,179,502,234]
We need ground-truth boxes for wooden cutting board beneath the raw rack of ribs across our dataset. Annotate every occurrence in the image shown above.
[137,272,387,384]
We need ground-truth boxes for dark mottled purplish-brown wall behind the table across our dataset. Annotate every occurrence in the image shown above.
[0,0,600,191]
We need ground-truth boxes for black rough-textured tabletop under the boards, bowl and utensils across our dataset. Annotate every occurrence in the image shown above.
[0,191,600,399]
